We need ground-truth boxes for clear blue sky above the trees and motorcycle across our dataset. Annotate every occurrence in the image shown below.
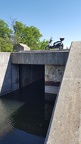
[0,0,81,46]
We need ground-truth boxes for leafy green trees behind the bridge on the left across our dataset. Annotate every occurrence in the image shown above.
[0,20,47,52]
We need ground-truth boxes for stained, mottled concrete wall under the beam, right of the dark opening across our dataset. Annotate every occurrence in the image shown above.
[45,65,65,102]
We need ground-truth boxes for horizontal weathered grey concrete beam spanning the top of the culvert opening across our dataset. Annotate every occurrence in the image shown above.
[11,50,69,65]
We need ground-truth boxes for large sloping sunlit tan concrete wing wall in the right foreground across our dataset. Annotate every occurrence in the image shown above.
[45,42,81,144]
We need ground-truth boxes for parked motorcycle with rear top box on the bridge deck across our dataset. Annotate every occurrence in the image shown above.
[45,37,64,50]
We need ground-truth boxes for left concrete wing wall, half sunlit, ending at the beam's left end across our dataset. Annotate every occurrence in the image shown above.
[0,52,11,95]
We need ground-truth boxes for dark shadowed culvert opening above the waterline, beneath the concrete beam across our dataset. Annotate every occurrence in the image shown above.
[19,64,45,88]
